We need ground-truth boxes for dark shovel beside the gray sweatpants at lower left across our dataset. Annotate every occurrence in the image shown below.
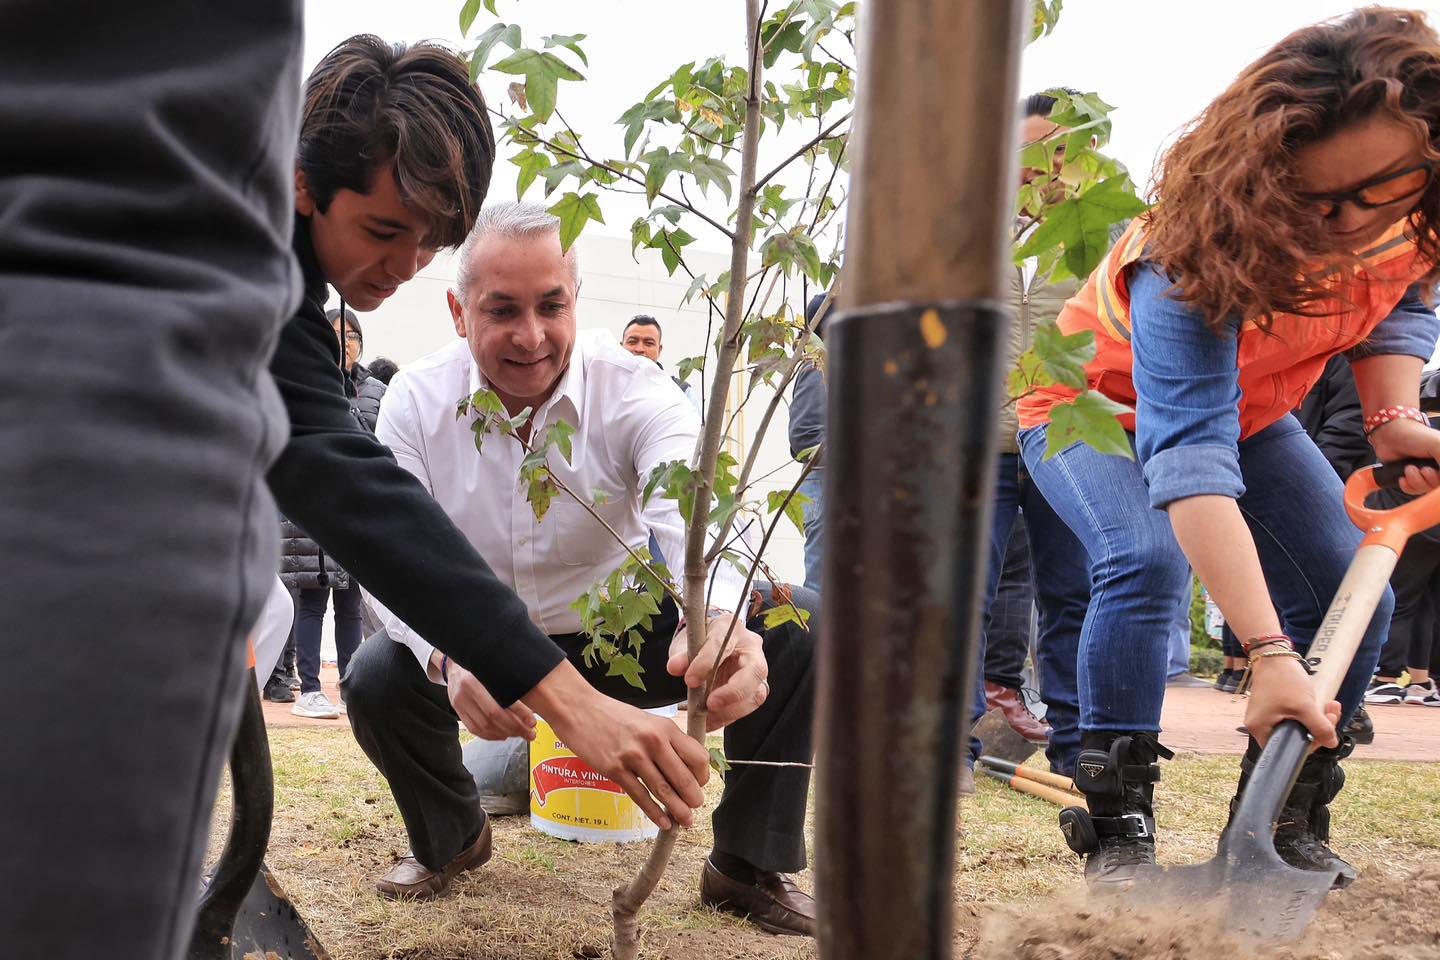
[186,642,330,960]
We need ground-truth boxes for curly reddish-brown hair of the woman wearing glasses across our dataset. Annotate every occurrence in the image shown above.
[1146,7,1440,332]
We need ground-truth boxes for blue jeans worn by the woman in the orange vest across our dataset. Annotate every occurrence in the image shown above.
[1020,416,1394,733]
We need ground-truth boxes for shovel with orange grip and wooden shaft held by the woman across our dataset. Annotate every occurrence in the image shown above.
[1126,461,1440,943]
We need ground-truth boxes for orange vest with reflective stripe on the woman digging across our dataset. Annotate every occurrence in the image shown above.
[1018,217,1426,438]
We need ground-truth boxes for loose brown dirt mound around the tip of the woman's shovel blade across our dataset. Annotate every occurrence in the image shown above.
[971,865,1440,960]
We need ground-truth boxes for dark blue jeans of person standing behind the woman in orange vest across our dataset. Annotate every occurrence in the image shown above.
[971,453,1090,776]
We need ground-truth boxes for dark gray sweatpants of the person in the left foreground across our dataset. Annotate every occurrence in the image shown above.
[0,0,301,960]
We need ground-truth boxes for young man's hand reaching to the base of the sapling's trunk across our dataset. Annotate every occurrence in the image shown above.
[524,662,710,829]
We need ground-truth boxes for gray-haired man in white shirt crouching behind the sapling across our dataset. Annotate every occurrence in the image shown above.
[344,203,815,936]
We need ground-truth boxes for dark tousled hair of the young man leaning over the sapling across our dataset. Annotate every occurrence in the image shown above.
[297,35,495,248]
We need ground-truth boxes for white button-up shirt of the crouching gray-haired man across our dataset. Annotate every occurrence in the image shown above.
[372,330,744,672]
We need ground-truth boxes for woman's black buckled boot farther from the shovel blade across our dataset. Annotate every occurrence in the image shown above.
[1060,731,1175,889]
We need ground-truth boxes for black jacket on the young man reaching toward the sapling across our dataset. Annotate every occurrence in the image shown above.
[268,217,564,705]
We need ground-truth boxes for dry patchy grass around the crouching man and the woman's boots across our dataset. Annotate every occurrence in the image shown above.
[212,725,1440,960]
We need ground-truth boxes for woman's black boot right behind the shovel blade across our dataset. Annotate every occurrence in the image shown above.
[1230,735,1355,889]
